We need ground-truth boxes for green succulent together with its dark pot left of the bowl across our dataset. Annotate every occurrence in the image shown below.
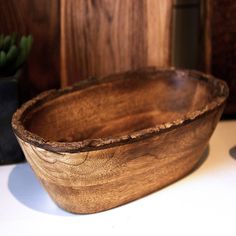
[0,33,32,165]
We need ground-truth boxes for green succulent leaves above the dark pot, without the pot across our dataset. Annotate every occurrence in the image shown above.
[0,33,33,76]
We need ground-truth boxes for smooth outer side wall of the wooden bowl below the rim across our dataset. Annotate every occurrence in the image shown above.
[18,107,223,213]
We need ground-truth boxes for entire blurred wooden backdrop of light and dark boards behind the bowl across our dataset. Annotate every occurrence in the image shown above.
[0,0,236,118]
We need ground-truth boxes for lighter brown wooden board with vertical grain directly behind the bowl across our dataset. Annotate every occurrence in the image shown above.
[61,0,172,86]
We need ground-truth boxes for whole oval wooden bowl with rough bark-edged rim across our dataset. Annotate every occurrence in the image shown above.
[12,68,228,213]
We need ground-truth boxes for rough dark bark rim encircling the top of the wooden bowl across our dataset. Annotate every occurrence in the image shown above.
[12,67,229,153]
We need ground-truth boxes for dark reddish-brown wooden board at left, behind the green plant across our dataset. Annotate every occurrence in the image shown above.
[0,0,60,98]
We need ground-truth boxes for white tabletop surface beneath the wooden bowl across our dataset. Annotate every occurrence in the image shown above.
[0,121,236,236]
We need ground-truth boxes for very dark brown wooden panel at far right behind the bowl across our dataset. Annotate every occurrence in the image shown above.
[209,0,236,117]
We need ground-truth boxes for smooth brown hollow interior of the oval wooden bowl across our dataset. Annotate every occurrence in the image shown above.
[23,71,217,142]
